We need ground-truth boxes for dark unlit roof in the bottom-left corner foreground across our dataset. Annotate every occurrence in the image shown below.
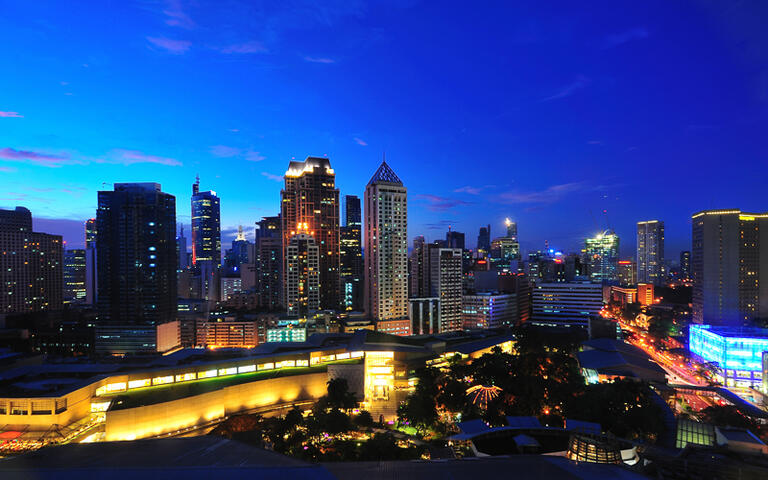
[0,436,333,480]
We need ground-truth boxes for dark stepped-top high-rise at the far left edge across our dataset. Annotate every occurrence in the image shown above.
[0,207,63,314]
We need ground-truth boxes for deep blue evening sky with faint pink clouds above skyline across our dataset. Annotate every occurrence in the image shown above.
[0,0,768,258]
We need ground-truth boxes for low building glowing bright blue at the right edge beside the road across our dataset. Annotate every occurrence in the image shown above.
[688,325,768,387]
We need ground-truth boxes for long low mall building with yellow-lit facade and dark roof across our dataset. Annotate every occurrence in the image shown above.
[0,330,512,456]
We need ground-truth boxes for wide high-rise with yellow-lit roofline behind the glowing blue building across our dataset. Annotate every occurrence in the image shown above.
[691,210,768,326]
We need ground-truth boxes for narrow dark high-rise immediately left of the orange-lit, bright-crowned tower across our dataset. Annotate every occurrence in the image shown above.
[256,215,284,311]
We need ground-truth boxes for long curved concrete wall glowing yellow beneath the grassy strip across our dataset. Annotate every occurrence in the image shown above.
[105,372,328,441]
